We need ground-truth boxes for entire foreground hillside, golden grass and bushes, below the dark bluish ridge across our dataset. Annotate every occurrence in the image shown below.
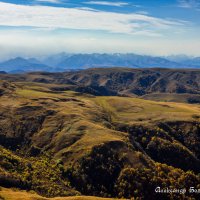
[0,81,200,199]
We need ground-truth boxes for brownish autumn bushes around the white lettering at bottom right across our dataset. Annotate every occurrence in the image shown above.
[115,163,200,200]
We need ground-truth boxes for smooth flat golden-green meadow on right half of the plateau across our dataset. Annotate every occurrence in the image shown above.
[92,97,200,124]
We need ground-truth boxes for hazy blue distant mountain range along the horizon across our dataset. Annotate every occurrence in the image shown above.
[0,53,200,73]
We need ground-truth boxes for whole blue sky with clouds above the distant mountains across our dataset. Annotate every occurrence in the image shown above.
[0,0,200,59]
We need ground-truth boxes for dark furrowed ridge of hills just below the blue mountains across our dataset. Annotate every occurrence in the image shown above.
[0,68,200,103]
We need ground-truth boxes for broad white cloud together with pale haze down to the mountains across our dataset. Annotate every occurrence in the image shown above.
[0,2,197,58]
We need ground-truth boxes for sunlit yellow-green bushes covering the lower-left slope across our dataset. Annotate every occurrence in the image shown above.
[0,147,77,197]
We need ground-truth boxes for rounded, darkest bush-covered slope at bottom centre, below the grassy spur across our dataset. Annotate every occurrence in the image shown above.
[66,145,123,197]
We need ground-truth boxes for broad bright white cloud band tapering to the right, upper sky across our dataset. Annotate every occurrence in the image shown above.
[0,2,184,36]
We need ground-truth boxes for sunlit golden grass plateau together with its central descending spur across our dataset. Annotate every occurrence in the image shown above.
[0,83,200,162]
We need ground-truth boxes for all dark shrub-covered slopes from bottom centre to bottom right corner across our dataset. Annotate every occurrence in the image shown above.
[65,145,200,200]
